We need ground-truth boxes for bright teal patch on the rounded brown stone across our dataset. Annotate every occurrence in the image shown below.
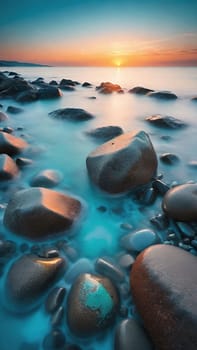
[80,280,113,321]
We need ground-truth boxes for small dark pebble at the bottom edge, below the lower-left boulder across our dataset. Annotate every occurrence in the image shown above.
[43,329,66,350]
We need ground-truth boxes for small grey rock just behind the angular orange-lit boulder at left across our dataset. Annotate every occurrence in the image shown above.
[30,169,61,188]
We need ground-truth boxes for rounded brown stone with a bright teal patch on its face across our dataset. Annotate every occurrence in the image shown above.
[67,274,119,337]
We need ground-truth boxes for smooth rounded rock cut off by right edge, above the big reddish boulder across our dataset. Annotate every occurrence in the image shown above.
[162,184,197,221]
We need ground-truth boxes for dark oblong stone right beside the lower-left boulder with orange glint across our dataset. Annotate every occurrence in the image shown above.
[45,287,66,313]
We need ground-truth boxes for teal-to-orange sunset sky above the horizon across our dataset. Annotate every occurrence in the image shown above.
[0,0,197,67]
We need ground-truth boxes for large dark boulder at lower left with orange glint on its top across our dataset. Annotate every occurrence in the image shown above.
[5,254,65,313]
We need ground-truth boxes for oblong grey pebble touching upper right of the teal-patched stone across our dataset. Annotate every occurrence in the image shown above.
[95,258,125,283]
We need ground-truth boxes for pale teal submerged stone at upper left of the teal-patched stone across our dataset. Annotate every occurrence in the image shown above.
[65,258,93,283]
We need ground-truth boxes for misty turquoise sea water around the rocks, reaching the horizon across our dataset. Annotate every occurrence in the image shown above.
[0,67,197,350]
